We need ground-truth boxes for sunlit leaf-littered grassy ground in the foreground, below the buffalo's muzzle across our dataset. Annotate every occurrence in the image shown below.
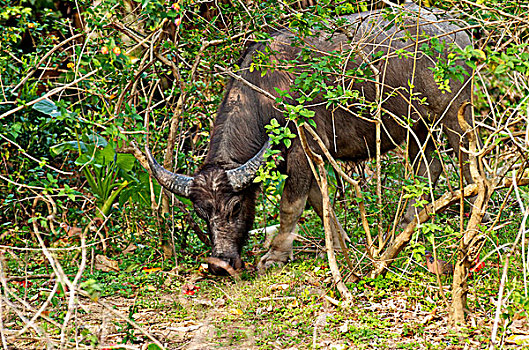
[4,241,529,349]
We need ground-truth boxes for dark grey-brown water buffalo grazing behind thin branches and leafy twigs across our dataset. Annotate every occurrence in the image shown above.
[146,5,472,274]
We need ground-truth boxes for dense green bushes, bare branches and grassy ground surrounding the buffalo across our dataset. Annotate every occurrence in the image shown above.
[0,0,529,349]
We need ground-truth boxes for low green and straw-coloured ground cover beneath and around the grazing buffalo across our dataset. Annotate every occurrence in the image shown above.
[0,179,529,350]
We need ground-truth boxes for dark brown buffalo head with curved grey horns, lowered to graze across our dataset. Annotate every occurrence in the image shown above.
[145,143,269,275]
